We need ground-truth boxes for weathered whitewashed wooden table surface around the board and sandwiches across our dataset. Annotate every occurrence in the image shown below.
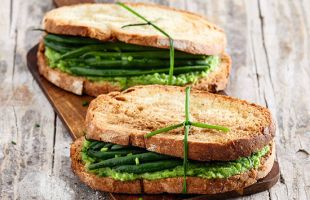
[0,0,310,200]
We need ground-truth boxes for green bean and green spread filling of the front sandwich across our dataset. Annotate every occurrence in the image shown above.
[81,140,270,181]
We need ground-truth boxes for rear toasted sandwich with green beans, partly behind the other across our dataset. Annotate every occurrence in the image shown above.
[37,3,231,96]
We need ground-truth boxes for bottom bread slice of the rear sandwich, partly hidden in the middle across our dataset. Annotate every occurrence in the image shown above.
[37,42,231,96]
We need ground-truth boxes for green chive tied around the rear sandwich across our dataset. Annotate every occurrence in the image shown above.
[116,2,174,85]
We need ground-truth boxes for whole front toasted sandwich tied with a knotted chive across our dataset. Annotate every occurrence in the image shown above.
[70,85,275,194]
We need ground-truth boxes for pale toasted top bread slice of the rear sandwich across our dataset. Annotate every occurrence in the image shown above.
[43,3,226,55]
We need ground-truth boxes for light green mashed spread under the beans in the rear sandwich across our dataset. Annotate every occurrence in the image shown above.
[45,47,220,89]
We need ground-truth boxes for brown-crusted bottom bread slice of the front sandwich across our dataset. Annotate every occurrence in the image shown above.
[70,138,275,194]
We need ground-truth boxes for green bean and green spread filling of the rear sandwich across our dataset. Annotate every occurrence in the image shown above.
[44,34,220,89]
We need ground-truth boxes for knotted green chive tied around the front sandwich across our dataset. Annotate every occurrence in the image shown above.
[144,87,230,193]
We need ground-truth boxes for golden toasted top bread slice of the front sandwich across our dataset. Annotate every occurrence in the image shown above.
[86,85,275,161]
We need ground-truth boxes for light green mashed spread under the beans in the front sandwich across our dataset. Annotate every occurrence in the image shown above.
[81,140,270,181]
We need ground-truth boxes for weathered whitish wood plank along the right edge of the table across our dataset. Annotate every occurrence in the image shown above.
[260,1,310,199]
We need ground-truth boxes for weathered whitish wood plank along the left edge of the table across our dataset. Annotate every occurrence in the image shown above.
[0,0,55,199]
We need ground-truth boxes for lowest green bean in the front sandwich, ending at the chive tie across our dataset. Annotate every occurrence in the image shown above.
[114,160,182,174]
